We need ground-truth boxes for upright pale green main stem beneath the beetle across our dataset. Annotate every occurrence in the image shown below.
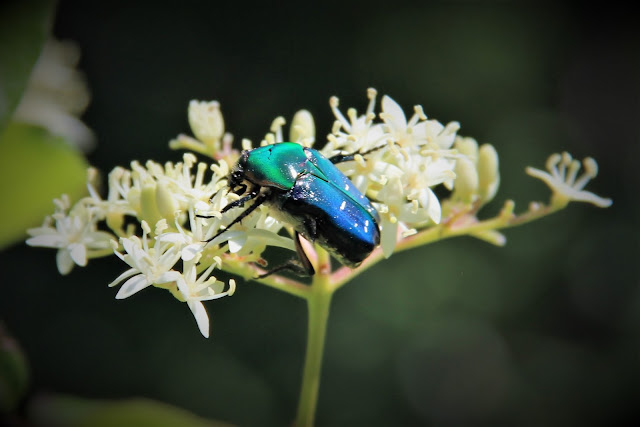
[295,250,333,427]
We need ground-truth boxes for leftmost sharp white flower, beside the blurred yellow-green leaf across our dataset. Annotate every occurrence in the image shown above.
[27,196,114,274]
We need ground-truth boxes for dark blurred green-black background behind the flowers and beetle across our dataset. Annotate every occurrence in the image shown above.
[0,0,640,426]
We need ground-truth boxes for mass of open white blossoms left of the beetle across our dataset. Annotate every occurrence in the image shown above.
[27,153,272,336]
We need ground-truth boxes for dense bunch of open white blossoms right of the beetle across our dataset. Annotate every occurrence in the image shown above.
[322,89,482,257]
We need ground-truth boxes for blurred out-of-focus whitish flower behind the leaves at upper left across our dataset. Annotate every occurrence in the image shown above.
[13,39,95,151]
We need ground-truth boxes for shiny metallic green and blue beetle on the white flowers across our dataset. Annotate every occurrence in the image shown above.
[208,142,380,277]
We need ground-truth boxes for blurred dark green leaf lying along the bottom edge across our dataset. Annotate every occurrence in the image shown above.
[27,395,235,427]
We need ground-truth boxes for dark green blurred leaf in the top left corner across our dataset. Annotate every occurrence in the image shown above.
[0,0,55,131]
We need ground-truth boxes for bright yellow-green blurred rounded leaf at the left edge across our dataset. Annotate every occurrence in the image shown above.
[0,122,88,248]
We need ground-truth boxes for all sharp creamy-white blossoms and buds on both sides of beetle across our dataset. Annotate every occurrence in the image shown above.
[27,89,610,336]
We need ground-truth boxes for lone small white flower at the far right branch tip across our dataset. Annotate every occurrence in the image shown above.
[526,152,613,208]
